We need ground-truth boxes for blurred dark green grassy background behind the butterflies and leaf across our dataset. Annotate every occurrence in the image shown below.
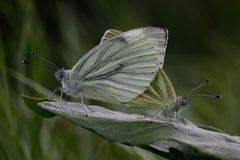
[0,0,240,160]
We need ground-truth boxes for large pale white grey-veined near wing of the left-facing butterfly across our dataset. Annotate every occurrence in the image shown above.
[69,27,168,102]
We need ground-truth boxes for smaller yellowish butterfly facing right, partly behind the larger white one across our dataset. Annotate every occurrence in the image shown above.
[125,68,190,125]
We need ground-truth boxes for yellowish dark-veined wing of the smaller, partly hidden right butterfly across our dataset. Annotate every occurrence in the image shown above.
[126,69,177,110]
